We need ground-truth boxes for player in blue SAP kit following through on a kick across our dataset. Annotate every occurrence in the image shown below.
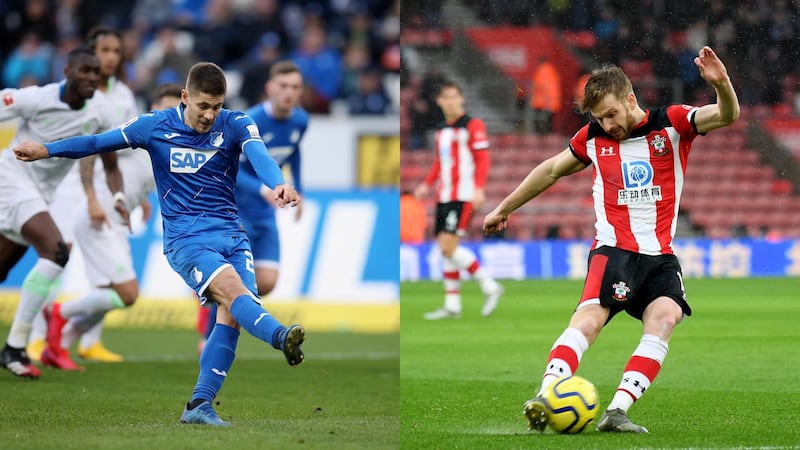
[14,62,305,426]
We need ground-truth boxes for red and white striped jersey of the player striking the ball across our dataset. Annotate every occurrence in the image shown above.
[569,105,698,255]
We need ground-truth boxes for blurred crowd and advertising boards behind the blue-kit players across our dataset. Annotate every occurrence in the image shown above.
[0,0,400,333]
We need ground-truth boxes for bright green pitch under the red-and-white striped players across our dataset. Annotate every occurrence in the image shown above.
[400,278,800,449]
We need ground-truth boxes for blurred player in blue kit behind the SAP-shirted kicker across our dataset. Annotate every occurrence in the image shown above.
[198,61,308,348]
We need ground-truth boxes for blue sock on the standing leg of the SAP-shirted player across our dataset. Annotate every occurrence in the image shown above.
[191,323,239,405]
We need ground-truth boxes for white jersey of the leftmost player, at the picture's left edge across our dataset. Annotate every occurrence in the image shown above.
[0,81,116,202]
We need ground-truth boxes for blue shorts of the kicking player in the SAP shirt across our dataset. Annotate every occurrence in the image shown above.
[166,231,260,304]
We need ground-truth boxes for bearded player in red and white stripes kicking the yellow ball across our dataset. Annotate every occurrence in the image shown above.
[484,47,739,433]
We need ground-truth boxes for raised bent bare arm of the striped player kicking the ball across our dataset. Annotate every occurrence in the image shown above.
[694,46,739,133]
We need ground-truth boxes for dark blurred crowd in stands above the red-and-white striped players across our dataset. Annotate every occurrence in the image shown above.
[403,0,800,126]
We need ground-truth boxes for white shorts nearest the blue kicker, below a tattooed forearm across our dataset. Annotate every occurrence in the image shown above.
[75,208,136,286]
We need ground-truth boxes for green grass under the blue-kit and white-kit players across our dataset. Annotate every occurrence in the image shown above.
[0,326,400,450]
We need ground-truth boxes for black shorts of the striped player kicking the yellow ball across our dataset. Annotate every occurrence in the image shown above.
[580,246,692,323]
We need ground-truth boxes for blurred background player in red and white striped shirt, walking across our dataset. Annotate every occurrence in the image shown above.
[414,81,503,320]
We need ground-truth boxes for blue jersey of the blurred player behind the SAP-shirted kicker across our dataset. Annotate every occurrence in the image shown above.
[236,101,308,220]
